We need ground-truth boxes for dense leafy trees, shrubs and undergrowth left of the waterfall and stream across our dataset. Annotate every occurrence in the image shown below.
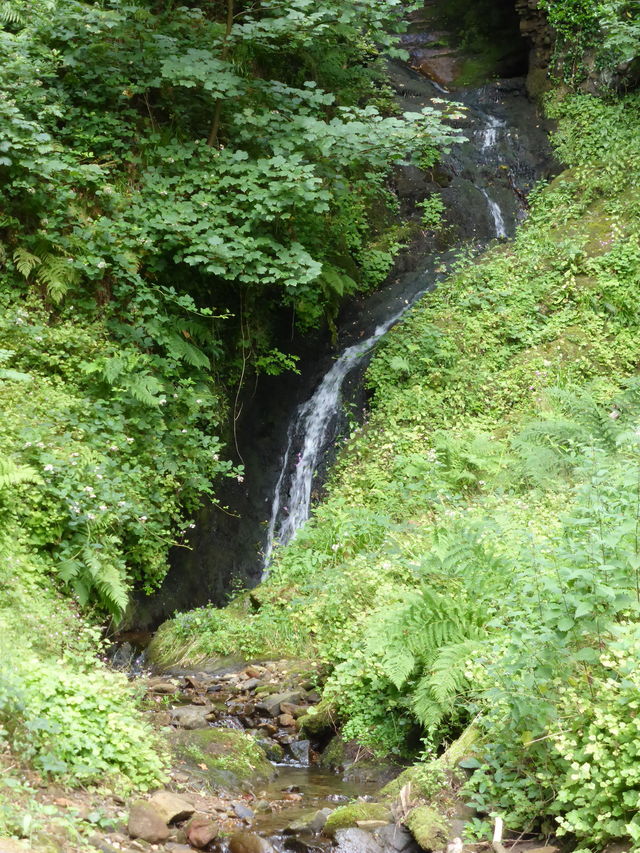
[0,0,456,834]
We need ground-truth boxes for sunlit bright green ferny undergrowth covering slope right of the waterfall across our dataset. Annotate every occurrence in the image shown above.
[156,90,640,850]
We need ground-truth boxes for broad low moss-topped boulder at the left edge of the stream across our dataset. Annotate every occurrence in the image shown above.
[172,729,275,789]
